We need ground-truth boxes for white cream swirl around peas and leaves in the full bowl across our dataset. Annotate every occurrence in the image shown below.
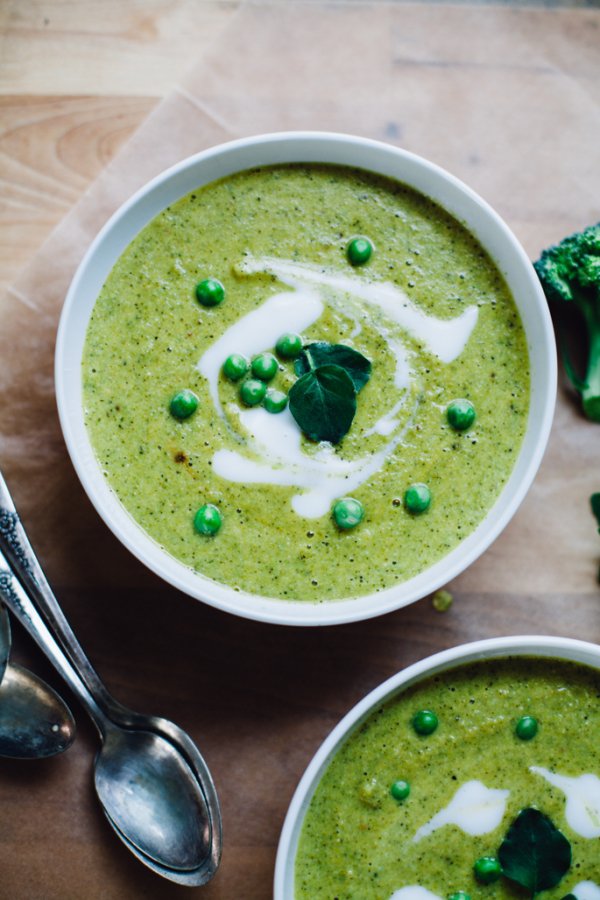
[197,256,478,519]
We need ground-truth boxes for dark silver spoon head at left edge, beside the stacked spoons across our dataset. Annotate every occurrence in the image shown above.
[0,663,75,759]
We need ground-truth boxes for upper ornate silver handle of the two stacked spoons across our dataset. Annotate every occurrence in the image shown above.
[0,472,120,718]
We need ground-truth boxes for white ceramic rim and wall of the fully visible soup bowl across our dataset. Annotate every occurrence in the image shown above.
[56,133,556,625]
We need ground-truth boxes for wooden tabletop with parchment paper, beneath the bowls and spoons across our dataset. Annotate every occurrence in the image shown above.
[0,0,600,900]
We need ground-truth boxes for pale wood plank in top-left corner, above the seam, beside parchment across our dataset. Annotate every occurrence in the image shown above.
[0,0,239,97]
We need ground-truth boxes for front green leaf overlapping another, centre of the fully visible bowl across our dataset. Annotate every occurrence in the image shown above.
[288,366,356,444]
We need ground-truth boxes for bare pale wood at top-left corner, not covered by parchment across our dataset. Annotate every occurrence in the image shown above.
[0,0,239,292]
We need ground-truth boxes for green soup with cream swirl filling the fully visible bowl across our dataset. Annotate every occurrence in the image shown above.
[83,166,529,600]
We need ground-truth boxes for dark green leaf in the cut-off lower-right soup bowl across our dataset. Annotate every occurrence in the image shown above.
[498,807,571,894]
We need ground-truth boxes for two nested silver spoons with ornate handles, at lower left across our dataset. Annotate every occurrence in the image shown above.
[0,475,221,885]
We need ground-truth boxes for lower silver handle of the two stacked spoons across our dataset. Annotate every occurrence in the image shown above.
[0,552,106,735]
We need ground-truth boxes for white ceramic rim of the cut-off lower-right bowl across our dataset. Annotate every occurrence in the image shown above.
[273,636,600,900]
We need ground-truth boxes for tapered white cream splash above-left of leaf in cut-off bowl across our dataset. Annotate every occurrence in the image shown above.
[413,781,510,841]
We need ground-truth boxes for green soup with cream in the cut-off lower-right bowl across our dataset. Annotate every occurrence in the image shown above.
[295,658,600,900]
